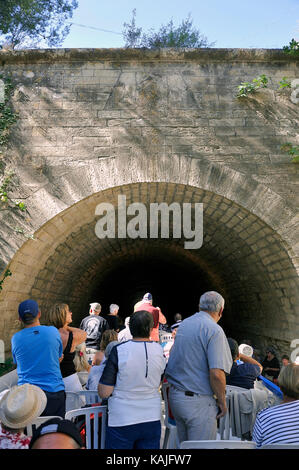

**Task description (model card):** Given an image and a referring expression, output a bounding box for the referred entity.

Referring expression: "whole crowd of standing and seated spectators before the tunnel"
[0,291,299,449]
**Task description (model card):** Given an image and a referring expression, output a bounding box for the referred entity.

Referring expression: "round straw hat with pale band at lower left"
[0,384,47,429]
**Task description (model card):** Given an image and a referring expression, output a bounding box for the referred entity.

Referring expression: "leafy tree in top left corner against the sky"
[0,0,78,49]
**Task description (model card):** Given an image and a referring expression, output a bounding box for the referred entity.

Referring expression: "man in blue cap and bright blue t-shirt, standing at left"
[11,299,65,418]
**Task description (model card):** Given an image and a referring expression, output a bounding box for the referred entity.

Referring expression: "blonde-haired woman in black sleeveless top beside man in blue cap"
[48,303,86,392]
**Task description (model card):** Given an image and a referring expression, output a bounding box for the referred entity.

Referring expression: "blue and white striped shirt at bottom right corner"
[252,400,299,447]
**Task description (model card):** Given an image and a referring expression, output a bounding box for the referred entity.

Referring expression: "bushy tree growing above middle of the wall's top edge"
[123,9,215,49]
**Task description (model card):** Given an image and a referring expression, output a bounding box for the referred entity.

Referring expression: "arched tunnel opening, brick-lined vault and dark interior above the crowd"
[1,182,299,352]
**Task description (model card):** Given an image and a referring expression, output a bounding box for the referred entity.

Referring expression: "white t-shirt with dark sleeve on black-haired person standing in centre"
[100,340,166,427]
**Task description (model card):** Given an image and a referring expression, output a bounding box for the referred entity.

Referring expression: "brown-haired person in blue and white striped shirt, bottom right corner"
[252,363,299,447]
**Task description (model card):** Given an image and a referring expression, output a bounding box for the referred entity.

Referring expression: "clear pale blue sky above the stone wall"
[61,0,299,48]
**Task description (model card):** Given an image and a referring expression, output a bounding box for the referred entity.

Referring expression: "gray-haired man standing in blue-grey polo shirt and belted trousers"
[165,291,233,442]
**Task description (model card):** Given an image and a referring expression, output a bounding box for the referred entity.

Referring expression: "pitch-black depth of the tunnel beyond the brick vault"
[86,253,231,332]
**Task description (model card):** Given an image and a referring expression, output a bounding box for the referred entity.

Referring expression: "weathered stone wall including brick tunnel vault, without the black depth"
[0,49,299,358]
